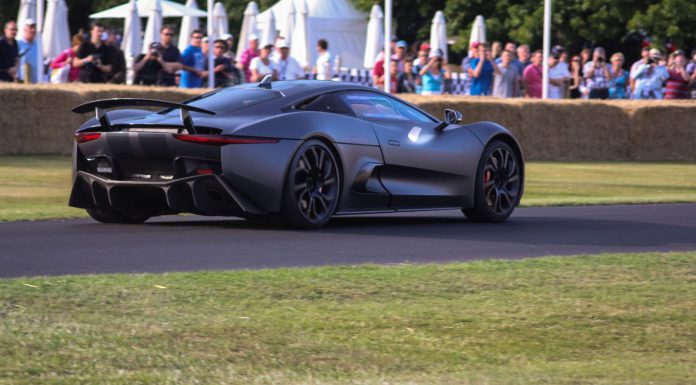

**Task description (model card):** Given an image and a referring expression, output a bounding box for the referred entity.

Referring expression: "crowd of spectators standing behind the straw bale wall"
[0,19,696,99]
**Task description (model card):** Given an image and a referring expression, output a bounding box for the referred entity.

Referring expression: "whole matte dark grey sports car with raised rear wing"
[70,80,524,228]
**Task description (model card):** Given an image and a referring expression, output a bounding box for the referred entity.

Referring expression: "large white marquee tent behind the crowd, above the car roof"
[258,0,367,68]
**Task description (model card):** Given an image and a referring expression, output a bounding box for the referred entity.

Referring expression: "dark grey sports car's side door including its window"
[341,91,482,209]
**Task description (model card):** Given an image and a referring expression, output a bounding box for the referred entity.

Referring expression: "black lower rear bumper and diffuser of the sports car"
[69,171,266,217]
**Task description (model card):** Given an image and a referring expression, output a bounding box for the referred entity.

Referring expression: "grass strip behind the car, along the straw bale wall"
[0,156,696,221]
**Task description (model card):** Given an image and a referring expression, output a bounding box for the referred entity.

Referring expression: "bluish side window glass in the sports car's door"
[341,92,433,123]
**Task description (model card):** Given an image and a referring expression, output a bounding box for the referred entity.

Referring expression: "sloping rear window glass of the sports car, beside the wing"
[163,88,282,113]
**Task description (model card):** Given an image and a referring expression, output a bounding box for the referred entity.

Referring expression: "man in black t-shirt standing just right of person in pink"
[73,23,111,83]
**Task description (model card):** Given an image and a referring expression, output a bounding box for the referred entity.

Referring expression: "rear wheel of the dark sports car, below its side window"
[281,139,341,229]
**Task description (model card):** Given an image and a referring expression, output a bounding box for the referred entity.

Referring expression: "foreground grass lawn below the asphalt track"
[0,252,696,385]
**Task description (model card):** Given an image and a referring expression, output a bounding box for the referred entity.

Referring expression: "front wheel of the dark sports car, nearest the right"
[462,140,522,222]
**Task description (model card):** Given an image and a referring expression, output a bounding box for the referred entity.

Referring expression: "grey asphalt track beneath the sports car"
[0,204,696,277]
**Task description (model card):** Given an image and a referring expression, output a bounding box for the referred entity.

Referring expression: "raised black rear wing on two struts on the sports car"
[72,98,215,134]
